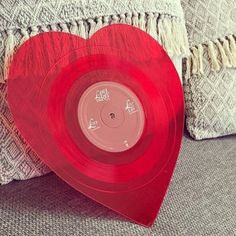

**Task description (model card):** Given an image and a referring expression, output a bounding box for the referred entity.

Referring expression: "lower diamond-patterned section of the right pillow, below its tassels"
[184,57,236,140]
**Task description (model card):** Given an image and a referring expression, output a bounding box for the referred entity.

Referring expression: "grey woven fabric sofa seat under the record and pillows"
[0,136,236,236]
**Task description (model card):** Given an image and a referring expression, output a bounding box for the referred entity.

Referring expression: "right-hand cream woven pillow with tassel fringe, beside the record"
[182,0,236,140]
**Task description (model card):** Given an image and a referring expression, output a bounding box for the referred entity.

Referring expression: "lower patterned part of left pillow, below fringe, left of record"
[0,84,49,184]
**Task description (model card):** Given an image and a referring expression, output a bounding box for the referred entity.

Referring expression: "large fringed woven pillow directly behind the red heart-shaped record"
[0,0,189,184]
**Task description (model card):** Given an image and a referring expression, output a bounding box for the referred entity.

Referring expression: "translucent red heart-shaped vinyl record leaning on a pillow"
[8,25,184,226]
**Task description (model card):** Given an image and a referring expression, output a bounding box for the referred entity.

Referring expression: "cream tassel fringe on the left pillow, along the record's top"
[0,11,188,83]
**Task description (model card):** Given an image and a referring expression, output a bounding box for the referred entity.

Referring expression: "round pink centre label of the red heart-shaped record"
[78,81,145,152]
